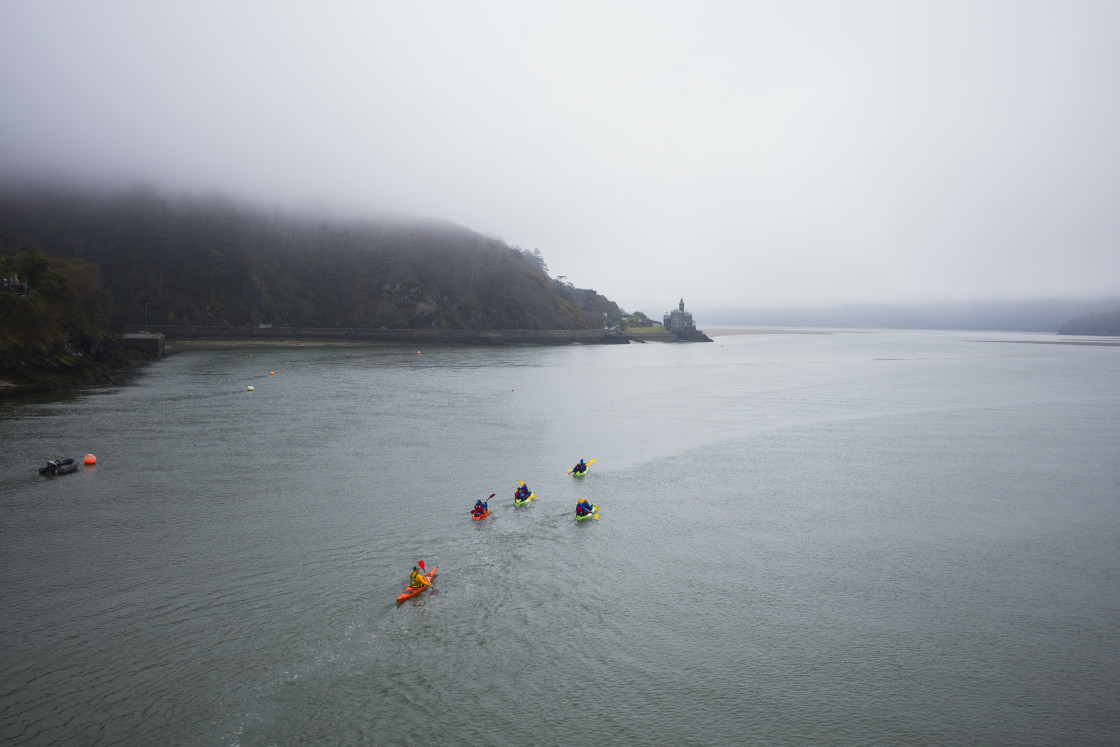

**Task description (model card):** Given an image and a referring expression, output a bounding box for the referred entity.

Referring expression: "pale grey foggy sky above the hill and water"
[0,0,1120,318]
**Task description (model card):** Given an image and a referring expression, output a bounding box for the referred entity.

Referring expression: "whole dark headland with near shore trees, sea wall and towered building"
[0,186,711,393]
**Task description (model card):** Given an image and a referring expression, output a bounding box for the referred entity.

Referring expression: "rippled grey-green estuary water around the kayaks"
[0,332,1120,746]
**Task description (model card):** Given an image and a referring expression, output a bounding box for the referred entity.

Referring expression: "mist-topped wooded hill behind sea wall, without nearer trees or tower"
[0,187,624,329]
